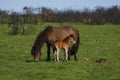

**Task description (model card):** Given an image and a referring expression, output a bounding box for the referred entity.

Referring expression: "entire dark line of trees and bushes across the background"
[0,6,120,34]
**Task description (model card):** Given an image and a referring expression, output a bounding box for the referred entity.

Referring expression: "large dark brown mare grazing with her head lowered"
[31,26,80,61]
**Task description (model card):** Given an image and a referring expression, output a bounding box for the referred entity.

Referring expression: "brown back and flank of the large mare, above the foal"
[47,26,77,41]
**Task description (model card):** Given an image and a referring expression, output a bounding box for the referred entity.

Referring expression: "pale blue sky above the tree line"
[0,0,120,11]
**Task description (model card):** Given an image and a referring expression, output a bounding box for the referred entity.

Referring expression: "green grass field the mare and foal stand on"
[0,23,120,80]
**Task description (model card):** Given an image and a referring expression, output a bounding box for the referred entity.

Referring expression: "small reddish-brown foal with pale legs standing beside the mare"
[54,35,76,61]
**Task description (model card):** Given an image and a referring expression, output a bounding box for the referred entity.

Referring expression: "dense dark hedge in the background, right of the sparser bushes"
[41,6,120,25]
